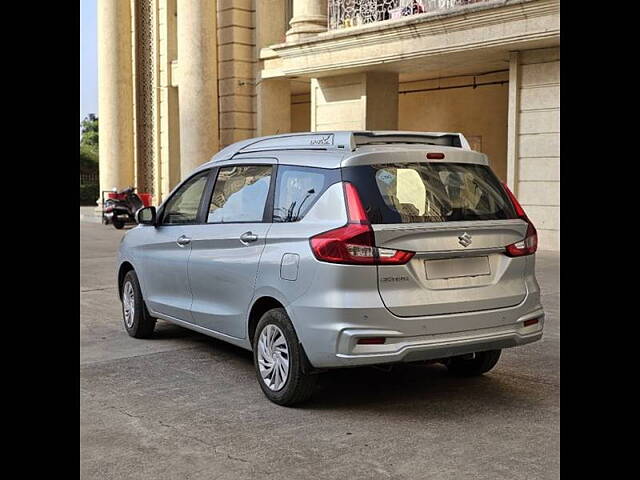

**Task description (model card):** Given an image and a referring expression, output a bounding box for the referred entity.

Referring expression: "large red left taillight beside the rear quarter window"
[310,182,415,265]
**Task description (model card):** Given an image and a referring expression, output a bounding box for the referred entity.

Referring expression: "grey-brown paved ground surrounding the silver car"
[80,222,560,480]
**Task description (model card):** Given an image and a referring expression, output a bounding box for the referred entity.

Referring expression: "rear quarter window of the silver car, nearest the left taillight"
[273,166,340,222]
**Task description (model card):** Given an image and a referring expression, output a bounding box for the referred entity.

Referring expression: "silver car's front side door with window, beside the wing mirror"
[141,170,211,323]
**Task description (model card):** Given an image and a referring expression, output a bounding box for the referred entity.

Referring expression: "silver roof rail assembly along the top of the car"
[212,131,471,161]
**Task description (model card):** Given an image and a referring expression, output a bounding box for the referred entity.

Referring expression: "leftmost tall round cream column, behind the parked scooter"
[97,0,134,202]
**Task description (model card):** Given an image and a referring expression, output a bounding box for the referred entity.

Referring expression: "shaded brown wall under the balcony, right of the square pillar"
[398,74,508,181]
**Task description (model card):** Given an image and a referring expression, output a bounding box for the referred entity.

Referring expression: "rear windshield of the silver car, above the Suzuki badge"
[342,162,517,224]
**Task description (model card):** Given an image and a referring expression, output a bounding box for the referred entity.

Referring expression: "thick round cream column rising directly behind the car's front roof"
[177,0,220,179]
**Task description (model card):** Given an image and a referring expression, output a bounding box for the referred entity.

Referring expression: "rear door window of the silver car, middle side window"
[207,165,273,223]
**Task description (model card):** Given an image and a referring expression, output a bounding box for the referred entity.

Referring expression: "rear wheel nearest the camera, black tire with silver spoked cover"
[253,308,317,406]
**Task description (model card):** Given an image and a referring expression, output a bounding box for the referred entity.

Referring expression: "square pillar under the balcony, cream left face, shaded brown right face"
[311,72,398,132]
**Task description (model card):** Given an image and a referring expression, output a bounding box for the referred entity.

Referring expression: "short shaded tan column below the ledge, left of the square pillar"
[256,78,291,137]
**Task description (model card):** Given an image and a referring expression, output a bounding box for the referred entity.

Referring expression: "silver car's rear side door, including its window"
[189,159,276,338]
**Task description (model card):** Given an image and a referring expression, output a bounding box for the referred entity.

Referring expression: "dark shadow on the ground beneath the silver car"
[153,322,539,416]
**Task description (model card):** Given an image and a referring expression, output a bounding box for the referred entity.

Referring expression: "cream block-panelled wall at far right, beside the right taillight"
[516,48,560,250]
